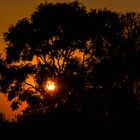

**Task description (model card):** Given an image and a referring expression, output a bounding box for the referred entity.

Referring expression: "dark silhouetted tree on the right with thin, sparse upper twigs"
[91,10,140,120]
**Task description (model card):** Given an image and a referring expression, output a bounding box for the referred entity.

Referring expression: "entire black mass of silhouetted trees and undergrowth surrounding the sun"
[0,1,140,139]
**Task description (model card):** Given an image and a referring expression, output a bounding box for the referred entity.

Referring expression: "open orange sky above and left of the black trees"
[0,0,140,118]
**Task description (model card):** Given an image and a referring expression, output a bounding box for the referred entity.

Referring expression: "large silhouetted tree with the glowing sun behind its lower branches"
[2,2,87,115]
